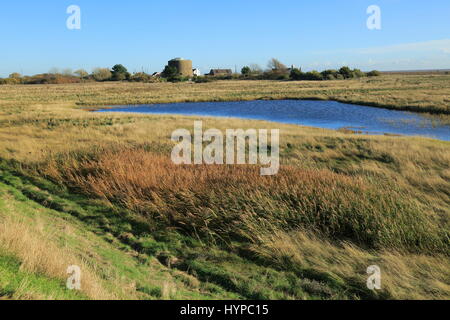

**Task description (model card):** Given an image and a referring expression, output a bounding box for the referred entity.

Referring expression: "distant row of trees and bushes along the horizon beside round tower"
[0,58,381,84]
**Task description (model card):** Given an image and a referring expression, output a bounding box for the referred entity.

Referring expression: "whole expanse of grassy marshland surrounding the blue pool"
[0,74,450,299]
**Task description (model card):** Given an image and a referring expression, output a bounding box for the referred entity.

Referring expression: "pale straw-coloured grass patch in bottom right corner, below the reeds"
[251,230,450,300]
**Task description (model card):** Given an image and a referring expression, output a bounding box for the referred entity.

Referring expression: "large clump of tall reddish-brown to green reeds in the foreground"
[46,149,449,253]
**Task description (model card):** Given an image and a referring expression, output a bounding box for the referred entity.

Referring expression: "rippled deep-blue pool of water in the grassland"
[98,100,450,141]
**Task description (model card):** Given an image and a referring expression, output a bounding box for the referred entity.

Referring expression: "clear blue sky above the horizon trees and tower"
[0,0,450,76]
